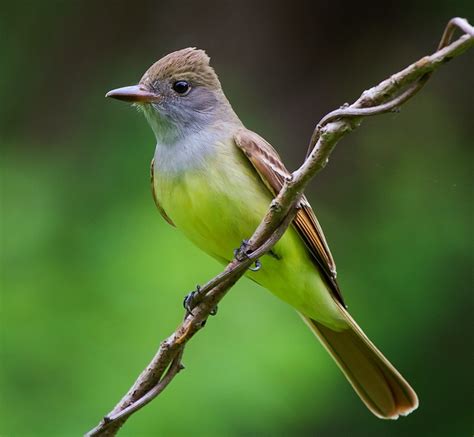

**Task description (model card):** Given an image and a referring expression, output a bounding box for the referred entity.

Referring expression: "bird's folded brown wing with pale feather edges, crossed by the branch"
[234,129,345,306]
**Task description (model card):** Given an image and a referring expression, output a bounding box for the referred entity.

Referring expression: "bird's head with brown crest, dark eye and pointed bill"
[106,48,227,143]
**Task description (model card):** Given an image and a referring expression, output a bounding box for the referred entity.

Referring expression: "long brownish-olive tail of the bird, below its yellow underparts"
[301,307,418,419]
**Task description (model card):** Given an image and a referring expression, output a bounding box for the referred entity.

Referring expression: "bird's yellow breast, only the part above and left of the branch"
[154,145,271,260]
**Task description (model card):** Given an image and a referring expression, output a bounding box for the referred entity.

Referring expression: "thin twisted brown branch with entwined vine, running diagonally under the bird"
[86,18,474,437]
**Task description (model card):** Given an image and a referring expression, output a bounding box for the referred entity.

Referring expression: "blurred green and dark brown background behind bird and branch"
[0,1,474,437]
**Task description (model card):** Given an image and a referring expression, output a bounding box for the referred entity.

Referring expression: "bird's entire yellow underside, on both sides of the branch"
[154,146,346,329]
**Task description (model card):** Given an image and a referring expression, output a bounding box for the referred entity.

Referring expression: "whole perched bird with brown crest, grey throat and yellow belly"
[107,48,418,419]
